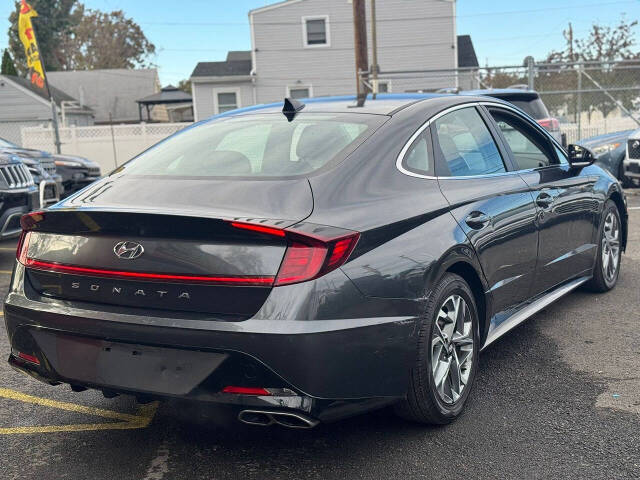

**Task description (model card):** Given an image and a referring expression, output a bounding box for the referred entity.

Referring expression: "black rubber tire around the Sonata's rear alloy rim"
[395,273,479,425]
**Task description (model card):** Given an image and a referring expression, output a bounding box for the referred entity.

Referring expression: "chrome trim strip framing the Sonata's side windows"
[396,101,566,180]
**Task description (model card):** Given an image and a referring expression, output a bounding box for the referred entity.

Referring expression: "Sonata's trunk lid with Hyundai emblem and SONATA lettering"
[21,179,312,319]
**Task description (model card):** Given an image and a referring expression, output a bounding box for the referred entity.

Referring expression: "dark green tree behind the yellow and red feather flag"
[8,0,80,75]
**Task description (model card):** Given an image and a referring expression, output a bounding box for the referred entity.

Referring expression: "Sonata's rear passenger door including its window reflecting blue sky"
[431,106,537,313]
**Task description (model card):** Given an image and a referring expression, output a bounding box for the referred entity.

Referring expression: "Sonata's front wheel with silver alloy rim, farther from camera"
[586,200,622,292]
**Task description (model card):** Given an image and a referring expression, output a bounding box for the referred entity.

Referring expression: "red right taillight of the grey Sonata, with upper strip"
[231,222,360,287]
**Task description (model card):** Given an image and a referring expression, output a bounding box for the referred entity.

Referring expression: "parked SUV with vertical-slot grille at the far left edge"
[0,153,40,240]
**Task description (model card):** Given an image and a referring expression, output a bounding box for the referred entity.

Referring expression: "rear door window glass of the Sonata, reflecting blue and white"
[434,107,506,177]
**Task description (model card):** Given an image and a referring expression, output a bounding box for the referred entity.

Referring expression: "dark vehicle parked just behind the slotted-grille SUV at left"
[0,138,64,207]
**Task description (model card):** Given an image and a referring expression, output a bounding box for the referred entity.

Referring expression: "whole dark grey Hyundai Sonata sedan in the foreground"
[5,95,627,428]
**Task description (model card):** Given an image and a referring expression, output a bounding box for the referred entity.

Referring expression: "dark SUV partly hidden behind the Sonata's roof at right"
[460,88,566,145]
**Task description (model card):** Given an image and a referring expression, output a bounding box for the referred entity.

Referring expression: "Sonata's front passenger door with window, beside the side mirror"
[488,106,598,294]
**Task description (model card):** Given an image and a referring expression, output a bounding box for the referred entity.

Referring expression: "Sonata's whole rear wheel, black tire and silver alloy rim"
[396,273,479,425]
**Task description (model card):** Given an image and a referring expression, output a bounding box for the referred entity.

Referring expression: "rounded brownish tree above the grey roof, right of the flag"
[62,5,156,70]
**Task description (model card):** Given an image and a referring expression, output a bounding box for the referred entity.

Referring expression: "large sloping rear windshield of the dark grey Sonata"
[124,113,388,177]
